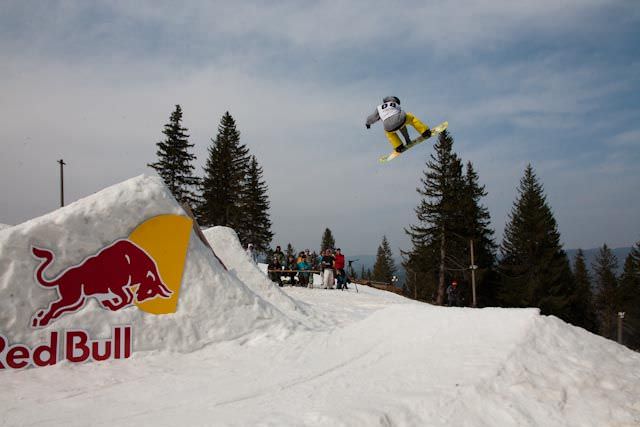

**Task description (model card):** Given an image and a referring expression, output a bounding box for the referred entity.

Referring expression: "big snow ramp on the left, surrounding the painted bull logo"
[0,175,297,352]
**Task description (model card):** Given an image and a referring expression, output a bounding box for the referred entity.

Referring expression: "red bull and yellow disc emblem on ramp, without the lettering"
[31,215,193,328]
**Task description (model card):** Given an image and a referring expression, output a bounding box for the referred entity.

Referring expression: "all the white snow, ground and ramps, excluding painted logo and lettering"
[0,176,640,426]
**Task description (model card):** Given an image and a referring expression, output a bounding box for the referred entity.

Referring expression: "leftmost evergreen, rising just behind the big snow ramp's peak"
[147,105,200,207]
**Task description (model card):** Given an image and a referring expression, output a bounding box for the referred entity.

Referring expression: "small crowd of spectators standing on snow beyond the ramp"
[247,243,349,289]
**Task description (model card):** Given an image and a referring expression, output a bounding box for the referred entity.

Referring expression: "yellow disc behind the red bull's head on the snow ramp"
[129,215,193,314]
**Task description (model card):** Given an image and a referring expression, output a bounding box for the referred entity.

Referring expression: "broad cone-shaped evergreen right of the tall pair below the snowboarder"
[500,165,574,320]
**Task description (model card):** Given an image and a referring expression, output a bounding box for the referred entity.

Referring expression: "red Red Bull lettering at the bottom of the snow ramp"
[0,326,133,371]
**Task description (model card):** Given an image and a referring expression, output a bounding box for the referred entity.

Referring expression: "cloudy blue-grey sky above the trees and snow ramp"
[0,0,640,254]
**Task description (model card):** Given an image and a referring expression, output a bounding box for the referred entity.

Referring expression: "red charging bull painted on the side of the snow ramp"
[32,239,173,328]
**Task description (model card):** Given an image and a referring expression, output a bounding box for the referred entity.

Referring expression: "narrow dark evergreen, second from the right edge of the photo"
[592,244,622,339]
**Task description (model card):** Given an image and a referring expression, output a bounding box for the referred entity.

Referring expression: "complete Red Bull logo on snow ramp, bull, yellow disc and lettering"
[0,215,193,370]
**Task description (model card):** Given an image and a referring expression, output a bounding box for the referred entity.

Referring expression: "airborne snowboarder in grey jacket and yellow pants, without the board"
[365,96,431,153]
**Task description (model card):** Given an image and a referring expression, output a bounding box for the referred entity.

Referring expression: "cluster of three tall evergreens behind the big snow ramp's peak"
[148,105,273,252]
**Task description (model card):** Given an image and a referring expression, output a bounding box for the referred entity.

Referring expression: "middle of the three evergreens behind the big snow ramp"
[198,111,250,236]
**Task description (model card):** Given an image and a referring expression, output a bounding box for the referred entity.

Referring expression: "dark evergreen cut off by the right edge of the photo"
[620,242,640,351]
